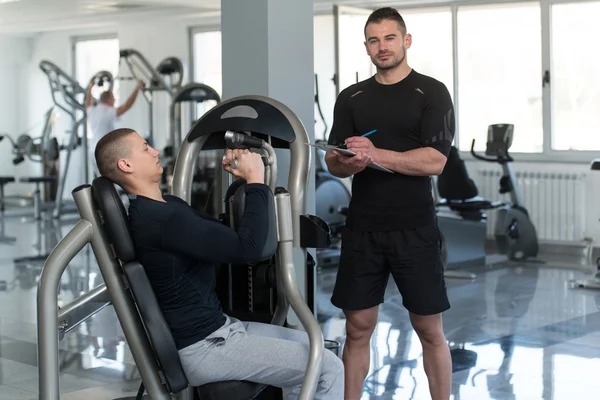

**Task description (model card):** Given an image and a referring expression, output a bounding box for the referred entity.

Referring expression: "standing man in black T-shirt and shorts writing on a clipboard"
[325,7,455,400]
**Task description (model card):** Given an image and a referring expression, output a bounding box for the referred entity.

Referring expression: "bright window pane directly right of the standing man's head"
[400,8,454,101]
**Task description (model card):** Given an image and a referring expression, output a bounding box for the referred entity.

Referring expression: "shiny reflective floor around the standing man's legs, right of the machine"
[319,257,600,400]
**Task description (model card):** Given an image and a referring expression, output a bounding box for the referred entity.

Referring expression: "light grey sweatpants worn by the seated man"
[179,316,344,400]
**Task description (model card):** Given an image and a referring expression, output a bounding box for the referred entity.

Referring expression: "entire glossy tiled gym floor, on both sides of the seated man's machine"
[0,211,600,400]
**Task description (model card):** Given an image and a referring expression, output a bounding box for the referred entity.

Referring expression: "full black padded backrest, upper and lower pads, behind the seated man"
[92,177,188,393]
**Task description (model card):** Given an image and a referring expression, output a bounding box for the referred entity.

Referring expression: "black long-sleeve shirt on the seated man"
[129,184,271,349]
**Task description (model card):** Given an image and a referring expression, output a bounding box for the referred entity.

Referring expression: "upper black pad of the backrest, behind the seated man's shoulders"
[92,176,135,263]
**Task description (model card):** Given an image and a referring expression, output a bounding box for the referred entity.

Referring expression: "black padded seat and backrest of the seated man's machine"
[92,177,276,400]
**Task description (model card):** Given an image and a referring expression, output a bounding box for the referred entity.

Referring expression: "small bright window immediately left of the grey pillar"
[192,31,223,118]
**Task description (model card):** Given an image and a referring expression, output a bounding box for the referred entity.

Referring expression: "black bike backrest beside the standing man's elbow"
[437,146,478,201]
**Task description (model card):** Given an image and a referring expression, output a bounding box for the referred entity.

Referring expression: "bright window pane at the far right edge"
[550,2,600,150]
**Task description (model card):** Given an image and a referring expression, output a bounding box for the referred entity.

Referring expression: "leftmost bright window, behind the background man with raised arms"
[75,38,119,104]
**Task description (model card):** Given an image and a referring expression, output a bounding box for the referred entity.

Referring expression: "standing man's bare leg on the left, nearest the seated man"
[342,306,379,400]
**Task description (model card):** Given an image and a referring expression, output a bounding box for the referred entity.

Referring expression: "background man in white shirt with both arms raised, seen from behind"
[85,80,144,175]
